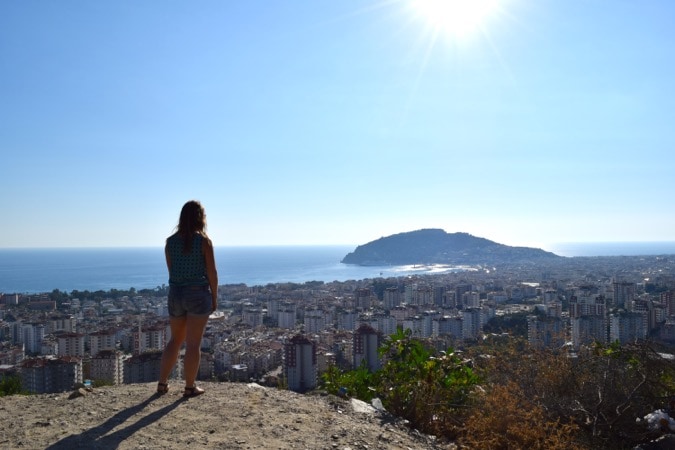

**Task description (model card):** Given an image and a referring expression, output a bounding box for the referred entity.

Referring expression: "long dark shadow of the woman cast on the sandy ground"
[47,394,183,450]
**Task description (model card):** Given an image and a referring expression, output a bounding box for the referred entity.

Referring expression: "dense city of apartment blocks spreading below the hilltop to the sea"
[0,256,675,393]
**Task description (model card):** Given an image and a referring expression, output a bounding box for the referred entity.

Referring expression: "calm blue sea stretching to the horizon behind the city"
[0,242,675,294]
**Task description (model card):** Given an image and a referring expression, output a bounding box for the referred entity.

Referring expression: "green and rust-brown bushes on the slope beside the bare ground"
[323,330,675,449]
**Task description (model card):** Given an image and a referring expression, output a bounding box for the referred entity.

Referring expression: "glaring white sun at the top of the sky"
[411,0,499,39]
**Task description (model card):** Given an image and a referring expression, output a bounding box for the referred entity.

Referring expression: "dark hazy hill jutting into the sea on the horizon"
[341,228,562,266]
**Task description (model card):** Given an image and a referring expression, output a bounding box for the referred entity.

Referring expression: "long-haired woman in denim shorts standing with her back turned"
[157,200,218,397]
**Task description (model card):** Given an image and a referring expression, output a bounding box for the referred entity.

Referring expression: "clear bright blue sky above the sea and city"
[0,0,675,248]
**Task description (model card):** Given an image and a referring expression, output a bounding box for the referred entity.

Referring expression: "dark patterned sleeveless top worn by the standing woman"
[166,233,209,286]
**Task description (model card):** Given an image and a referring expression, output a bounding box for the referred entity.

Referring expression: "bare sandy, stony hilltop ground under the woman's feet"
[0,382,446,450]
